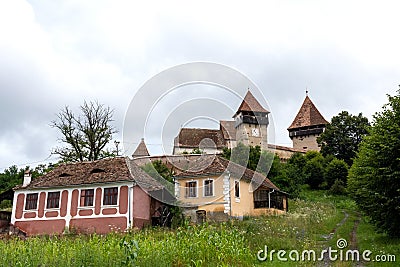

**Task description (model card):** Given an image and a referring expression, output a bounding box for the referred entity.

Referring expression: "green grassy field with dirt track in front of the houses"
[0,191,400,266]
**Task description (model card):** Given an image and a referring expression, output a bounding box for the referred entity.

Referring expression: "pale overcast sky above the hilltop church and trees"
[0,0,400,170]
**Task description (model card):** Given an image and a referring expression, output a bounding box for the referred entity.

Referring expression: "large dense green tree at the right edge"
[348,89,400,236]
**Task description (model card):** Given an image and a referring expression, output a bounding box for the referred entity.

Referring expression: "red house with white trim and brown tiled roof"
[11,158,172,235]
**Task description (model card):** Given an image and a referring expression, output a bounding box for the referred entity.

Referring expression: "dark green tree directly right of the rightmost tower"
[317,111,369,166]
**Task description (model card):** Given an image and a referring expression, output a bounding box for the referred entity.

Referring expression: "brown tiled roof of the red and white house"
[15,157,162,191]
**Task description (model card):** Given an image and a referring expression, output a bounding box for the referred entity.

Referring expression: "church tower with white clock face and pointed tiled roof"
[233,90,269,150]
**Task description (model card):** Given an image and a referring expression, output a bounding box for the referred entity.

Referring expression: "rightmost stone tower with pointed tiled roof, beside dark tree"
[288,92,328,151]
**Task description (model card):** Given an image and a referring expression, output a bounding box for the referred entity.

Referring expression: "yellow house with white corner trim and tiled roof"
[174,155,288,221]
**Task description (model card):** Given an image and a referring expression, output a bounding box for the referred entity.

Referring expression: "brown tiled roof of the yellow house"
[175,155,279,190]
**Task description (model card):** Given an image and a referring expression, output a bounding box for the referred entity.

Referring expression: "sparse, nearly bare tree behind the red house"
[51,101,116,162]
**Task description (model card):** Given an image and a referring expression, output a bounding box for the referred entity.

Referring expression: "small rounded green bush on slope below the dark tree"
[325,159,349,191]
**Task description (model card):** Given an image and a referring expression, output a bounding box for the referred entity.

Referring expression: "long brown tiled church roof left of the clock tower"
[175,128,225,148]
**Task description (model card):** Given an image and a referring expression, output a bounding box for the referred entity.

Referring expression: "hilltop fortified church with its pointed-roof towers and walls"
[136,90,328,161]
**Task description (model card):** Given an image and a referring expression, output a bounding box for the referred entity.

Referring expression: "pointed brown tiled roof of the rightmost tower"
[288,96,328,130]
